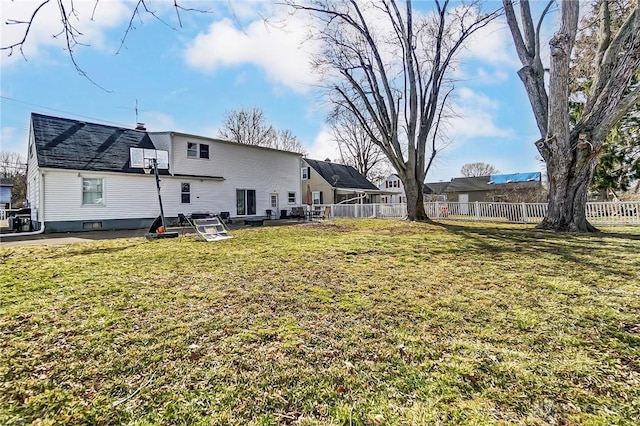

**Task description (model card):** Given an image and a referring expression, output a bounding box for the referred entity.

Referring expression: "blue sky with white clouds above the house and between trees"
[0,0,552,181]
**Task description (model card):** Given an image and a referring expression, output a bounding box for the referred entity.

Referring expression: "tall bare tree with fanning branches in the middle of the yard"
[288,0,499,220]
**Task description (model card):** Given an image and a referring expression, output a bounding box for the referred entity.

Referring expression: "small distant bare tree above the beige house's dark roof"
[330,109,388,182]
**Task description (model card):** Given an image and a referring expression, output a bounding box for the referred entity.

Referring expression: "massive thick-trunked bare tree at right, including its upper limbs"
[503,0,640,231]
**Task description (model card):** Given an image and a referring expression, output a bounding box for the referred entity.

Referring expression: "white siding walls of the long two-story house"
[35,133,301,222]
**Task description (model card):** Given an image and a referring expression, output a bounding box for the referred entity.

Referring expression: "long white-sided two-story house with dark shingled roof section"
[27,114,301,232]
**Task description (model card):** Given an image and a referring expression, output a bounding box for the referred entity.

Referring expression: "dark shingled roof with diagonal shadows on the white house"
[31,113,168,174]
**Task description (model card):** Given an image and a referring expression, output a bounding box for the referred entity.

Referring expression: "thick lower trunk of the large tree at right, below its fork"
[538,137,598,232]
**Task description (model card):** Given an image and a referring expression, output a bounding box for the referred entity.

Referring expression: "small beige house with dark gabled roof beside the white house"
[300,158,385,204]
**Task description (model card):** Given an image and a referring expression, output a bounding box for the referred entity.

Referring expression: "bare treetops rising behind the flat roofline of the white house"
[218,107,306,155]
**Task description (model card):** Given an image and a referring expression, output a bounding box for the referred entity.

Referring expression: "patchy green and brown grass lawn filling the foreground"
[0,220,640,425]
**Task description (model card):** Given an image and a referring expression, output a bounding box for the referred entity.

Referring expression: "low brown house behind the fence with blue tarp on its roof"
[424,172,545,203]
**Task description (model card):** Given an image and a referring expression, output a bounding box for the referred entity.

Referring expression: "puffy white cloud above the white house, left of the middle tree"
[185,10,318,92]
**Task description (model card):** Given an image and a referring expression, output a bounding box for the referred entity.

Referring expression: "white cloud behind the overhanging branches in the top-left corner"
[0,0,131,67]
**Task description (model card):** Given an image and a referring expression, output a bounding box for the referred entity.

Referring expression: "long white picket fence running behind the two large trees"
[322,201,640,225]
